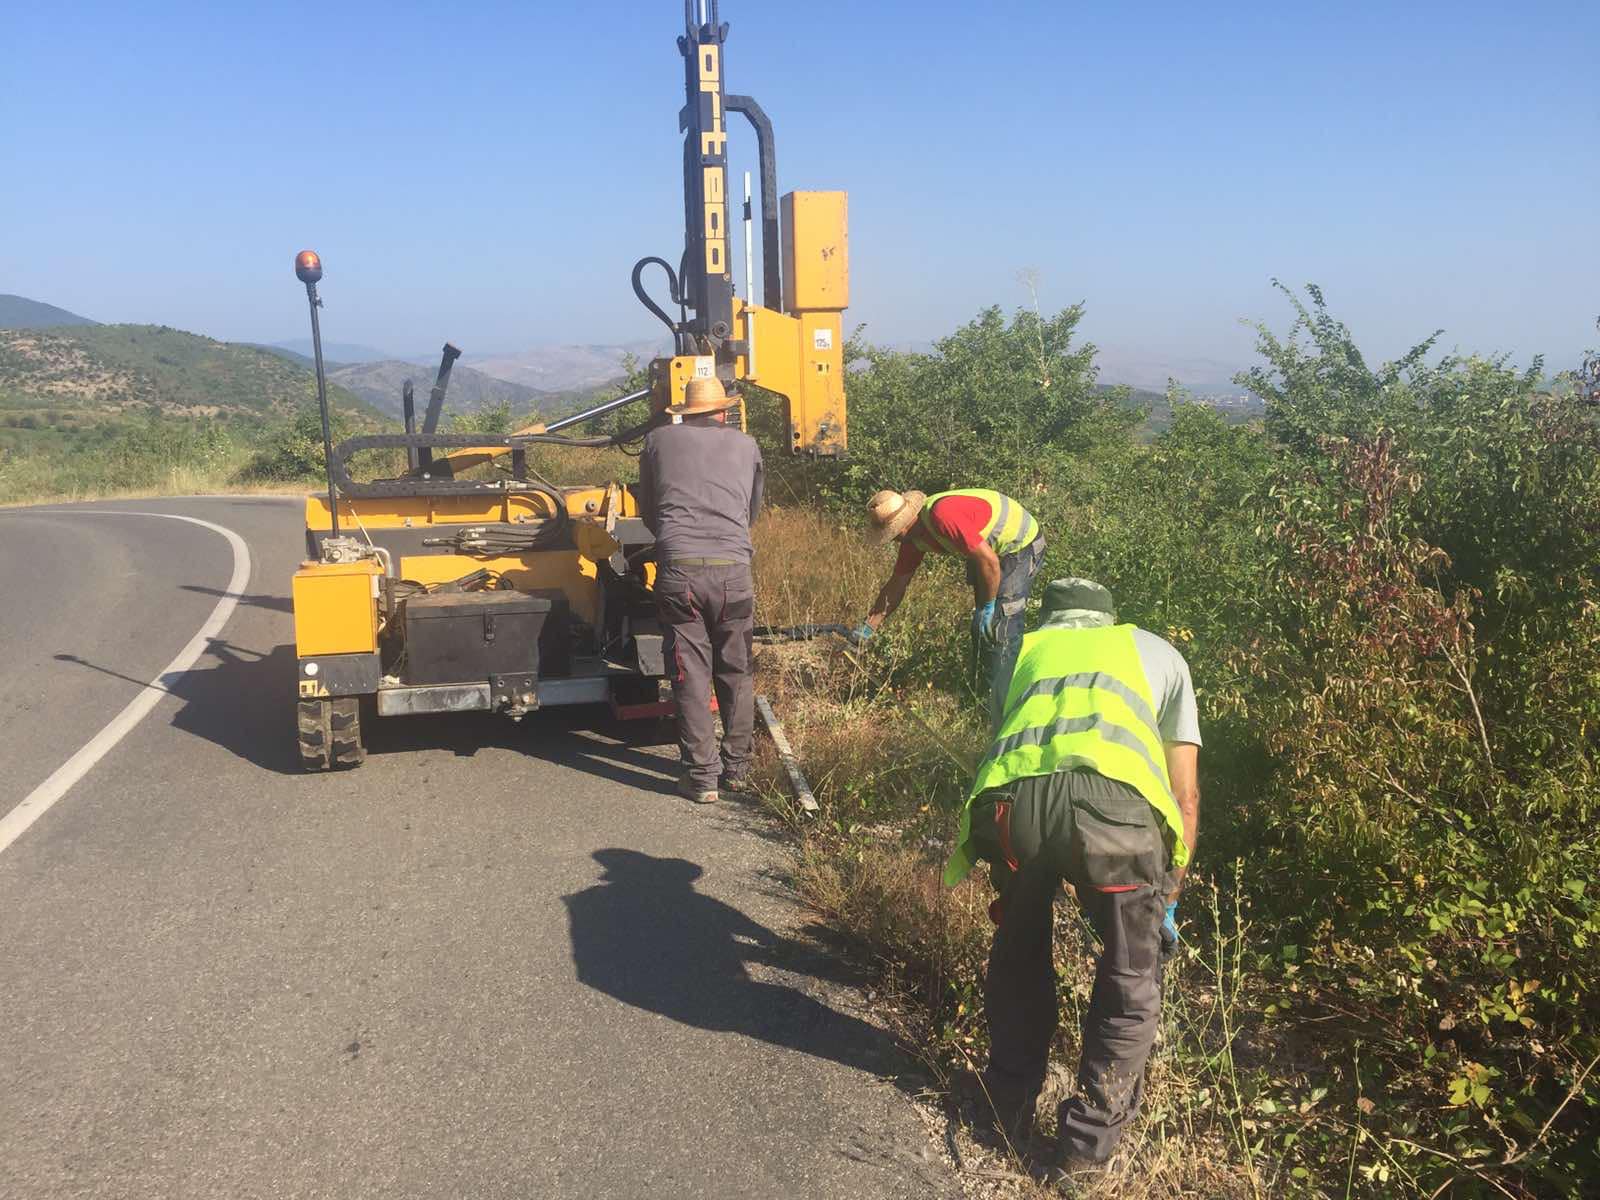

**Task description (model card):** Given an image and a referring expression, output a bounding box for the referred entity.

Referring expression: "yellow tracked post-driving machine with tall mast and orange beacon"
[293,0,850,770]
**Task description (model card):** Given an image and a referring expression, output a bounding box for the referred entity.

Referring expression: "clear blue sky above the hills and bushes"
[0,0,1600,377]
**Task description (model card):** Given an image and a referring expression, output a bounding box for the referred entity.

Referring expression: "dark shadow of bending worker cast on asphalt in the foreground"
[563,848,922,1091]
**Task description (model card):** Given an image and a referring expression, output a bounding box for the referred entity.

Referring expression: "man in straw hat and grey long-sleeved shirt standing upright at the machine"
[637,379,762,803]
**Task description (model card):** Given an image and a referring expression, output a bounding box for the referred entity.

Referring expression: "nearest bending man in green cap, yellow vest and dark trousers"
[944,579,1200,1189]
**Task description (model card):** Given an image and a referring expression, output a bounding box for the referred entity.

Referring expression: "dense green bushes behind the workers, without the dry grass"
[821,288,1600,1197]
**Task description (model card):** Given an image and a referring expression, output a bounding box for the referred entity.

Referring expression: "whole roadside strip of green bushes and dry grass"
[758,288,1600,1198]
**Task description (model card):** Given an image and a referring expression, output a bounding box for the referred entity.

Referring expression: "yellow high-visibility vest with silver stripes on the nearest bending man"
[944,626,1189,886]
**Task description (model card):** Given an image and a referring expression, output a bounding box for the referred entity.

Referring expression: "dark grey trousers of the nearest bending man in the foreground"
[973,770,1171,1162]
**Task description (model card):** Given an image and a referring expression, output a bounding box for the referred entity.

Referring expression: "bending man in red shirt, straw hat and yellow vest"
[856,488,1045,728]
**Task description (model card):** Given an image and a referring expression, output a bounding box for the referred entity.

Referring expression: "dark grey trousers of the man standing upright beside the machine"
[656,560,755,792]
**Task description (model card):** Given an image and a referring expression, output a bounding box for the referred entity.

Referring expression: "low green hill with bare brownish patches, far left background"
[0,325,365,419]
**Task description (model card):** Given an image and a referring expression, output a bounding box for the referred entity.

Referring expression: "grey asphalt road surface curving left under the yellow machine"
[0,499,960,1200]
